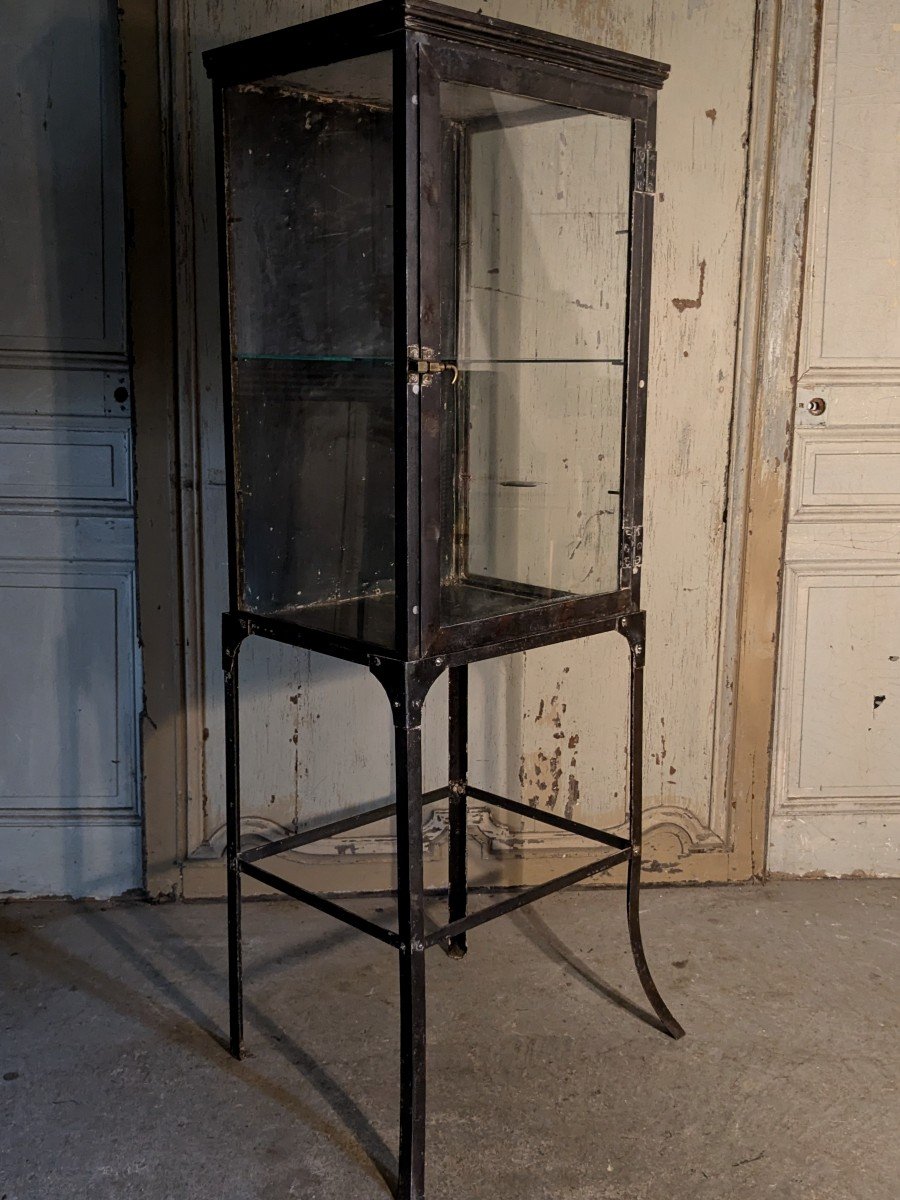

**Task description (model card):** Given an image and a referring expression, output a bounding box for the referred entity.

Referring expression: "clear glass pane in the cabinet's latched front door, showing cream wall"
[440,83,631,625]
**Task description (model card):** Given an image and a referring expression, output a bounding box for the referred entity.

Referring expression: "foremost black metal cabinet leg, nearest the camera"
[395,716,425,1200]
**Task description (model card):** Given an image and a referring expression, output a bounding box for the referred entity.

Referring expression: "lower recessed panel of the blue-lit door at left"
[0,560,139,822]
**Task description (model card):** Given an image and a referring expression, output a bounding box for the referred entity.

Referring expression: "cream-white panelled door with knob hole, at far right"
[768,0,900,875]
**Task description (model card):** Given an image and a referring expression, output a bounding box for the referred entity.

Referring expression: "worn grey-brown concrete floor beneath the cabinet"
[0,881,900,1200]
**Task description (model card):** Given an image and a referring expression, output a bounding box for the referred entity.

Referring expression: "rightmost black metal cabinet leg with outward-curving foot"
[623,613,684,1038]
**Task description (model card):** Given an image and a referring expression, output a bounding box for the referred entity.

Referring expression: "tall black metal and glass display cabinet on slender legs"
[204,0,683,1200]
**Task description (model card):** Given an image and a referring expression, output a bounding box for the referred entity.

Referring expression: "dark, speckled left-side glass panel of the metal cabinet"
[224,53,395,646]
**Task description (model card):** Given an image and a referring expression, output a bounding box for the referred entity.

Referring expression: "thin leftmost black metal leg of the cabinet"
[224,642,244,1058]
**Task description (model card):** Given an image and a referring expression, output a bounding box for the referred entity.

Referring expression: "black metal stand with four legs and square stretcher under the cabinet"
[223,612,684,1200]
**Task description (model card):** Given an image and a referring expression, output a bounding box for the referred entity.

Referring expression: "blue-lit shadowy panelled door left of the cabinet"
[0,0,142,895]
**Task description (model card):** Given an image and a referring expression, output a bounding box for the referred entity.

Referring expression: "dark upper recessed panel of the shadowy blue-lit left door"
[0,0,126,355]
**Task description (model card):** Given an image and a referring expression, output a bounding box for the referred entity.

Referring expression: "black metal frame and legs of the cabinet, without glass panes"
[204,0,683,1200]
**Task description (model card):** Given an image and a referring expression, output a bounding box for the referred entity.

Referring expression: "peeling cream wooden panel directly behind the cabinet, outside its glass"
[172,0,756,887]
